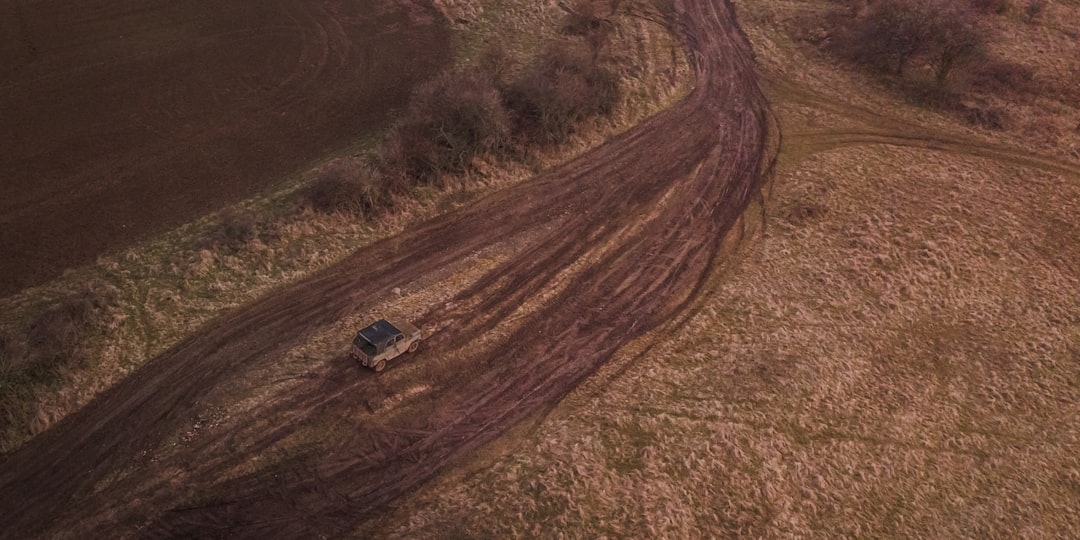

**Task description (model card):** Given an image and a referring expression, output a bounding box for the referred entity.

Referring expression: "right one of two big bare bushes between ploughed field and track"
[507,43,622,144]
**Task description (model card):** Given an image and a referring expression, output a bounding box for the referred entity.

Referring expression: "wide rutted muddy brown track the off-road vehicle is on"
[0,0,775,538]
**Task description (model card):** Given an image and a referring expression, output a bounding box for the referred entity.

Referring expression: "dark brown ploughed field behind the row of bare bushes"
[0,0,450,296]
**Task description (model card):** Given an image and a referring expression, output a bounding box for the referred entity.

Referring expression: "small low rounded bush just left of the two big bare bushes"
[300,159,389,216]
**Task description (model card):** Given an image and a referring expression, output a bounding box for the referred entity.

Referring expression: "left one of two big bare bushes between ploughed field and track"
[380,71,510,183]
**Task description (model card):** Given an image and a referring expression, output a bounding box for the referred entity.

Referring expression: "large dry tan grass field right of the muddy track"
[362,1,1080,538]
